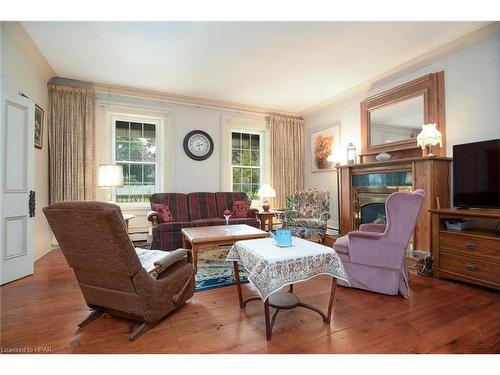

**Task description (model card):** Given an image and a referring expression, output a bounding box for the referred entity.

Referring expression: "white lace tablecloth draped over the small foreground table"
[226,237,349,301]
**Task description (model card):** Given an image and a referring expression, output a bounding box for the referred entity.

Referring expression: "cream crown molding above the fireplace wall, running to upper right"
[300,21,500,117]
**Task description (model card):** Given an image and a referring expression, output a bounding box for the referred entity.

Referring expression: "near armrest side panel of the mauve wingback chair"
[347,231,402,269]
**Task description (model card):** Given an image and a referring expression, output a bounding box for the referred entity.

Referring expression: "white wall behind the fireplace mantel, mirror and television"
[305,37,500,229]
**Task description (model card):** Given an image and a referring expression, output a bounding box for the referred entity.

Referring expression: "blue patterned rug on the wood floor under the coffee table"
[195,246,248,292]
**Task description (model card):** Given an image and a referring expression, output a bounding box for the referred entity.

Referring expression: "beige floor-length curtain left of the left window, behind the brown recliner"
[48,84,95,203]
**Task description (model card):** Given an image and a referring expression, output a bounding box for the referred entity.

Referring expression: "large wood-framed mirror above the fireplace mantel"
[361,72,445,162]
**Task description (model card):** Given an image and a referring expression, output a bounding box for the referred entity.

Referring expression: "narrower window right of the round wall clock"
[231,131,262,200]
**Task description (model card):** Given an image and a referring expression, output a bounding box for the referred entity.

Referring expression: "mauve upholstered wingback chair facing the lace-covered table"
[333,189,424,298]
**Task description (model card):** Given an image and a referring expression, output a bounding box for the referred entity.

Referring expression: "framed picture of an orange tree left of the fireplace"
[311,124,340,172]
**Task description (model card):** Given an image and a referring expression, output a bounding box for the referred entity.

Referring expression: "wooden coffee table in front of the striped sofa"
[181,224,269,273]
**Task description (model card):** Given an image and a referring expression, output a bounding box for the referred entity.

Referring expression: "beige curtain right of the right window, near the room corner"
[269,114,304,208]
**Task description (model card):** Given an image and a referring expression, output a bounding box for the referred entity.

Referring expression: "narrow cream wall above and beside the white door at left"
[1,22,55,259]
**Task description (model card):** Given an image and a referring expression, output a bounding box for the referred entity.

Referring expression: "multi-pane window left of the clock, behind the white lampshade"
[114,119,158,203]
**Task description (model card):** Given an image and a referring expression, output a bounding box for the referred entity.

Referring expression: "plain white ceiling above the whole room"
[22,22,488,112]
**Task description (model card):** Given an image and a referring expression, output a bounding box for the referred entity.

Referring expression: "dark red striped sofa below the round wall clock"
[150,192,259,251]
